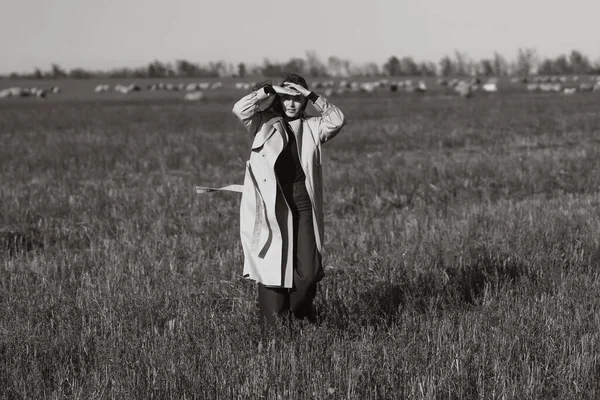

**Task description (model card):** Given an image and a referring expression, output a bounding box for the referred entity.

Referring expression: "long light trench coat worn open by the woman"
[233,89,346,288]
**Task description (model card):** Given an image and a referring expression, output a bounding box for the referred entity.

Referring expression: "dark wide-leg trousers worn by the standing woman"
[258,182,324,323]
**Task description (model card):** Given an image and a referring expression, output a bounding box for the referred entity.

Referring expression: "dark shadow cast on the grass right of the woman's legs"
[323,248,536,329]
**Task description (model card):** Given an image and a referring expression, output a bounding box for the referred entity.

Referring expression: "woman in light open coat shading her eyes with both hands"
[233,74,345,323]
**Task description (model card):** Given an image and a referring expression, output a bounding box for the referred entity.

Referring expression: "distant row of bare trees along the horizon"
[3,48,600,79]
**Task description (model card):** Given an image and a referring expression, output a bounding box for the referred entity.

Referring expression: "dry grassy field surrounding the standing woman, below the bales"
[0,82,600,399]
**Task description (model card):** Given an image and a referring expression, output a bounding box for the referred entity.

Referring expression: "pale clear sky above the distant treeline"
[0,0,600,74]
